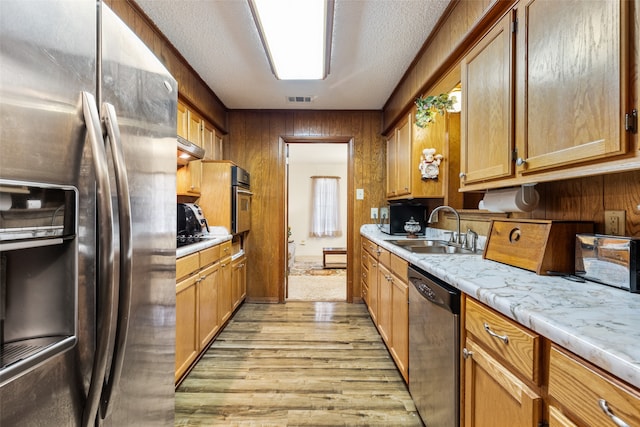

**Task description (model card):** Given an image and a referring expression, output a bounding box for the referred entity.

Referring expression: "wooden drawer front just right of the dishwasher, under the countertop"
[465,298,540,385]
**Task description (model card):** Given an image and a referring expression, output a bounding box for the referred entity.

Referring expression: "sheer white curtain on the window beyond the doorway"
[310,176,342,237]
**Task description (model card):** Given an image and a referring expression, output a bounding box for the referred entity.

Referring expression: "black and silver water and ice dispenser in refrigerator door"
[0,180,78,386]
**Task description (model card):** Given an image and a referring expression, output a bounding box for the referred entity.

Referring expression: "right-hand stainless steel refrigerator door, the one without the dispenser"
[93,5,178,426]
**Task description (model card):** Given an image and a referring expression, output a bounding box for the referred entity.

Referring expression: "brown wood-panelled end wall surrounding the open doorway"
[225,111,386,302]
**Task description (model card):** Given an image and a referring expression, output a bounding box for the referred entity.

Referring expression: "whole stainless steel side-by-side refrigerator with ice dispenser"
[0,0,177,427]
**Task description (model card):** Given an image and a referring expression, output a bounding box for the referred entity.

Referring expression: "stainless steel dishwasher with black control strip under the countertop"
[409,265,460,427]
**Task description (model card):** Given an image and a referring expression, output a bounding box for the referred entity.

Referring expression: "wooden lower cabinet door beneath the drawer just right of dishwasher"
[464,339,542,427]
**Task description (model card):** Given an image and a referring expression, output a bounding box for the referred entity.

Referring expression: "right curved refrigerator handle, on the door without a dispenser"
[100,102,133,419]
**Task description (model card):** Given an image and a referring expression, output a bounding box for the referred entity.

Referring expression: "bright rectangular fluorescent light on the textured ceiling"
[249,0,334,80]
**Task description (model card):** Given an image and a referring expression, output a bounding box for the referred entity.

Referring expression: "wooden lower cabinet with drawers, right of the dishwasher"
[462,297,640,427]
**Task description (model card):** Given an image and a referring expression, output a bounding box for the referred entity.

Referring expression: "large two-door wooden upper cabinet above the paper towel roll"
[461,0,630,190]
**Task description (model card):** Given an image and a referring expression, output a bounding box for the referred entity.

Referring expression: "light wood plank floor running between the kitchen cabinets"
[175,302,423,426]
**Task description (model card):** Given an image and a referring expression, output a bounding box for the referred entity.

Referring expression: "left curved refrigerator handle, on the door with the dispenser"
[82,92,118,427]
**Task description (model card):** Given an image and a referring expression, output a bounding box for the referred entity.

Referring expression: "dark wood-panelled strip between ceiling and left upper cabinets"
[104,0,227,133]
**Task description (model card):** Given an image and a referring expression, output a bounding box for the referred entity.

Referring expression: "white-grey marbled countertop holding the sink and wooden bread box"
[360,224,640,388]
